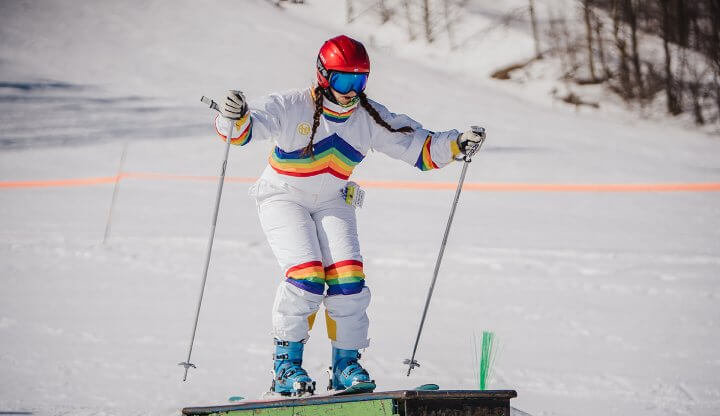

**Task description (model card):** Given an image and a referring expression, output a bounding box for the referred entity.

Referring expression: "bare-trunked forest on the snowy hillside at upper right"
[282,0,720,125]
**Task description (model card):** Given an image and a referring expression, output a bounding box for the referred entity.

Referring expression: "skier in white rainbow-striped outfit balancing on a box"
[215,36,481,395]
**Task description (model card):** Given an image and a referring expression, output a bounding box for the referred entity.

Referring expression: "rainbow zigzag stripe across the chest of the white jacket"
[268,133,365,179]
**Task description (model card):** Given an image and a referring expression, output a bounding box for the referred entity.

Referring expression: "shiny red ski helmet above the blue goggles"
[317,35,370,88]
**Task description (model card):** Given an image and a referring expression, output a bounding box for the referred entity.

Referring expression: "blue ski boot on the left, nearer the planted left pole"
[270,339,315,396]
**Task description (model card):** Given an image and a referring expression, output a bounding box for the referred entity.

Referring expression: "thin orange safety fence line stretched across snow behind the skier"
[0,172,720,192]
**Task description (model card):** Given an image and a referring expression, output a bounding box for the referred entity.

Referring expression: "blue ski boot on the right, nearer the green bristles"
[328,347,375,393]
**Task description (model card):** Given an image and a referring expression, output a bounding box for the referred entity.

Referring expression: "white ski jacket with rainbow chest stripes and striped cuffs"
[215,88,460,200]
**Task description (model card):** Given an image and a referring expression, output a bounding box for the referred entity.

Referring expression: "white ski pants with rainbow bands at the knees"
[250,179,370,349]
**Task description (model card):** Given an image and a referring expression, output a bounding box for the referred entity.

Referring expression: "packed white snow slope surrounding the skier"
[0,0,720,415]
